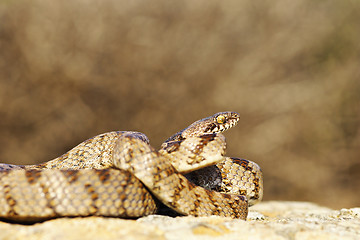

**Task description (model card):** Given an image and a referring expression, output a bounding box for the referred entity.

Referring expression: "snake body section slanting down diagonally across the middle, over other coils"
[113,137,248,219]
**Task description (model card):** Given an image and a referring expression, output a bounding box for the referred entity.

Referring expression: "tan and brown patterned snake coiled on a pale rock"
[0,111,263,222]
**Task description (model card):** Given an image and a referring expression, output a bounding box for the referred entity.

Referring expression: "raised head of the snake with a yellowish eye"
[181,112,240,138]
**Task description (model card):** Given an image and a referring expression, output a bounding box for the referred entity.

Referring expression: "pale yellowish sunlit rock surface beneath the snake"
[0,201,360,240]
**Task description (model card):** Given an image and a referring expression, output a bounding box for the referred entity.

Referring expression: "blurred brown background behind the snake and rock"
[0,0,360,208]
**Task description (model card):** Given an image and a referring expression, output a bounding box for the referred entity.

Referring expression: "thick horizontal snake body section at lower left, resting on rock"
[0,169,157,221]
